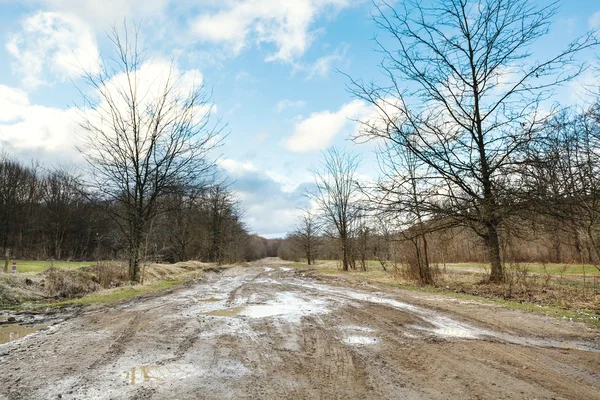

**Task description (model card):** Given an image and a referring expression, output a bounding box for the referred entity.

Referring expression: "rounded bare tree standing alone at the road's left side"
[80,25,219,282]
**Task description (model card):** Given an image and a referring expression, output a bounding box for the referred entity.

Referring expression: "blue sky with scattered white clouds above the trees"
[0,0,600,237]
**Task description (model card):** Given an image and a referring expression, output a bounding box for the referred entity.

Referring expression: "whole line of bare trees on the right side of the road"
[278,0,600,283]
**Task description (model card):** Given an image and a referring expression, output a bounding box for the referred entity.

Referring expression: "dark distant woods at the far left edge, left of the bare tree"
[0,154,109,259]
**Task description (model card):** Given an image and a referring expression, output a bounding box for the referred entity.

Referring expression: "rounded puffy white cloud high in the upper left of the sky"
[6,11,99,88]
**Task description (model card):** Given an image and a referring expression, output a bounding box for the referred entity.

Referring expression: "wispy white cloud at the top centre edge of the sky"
[193,0,351,62]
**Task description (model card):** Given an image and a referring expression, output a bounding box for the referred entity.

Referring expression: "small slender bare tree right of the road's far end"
[309,148,360,271]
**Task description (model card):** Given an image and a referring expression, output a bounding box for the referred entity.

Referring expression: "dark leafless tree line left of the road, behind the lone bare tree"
[0,154,276,263]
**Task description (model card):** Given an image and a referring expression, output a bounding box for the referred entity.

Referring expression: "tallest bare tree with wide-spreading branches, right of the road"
[350,0,598,282]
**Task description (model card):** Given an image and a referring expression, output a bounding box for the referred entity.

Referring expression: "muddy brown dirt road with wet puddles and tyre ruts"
[0,261,600,399]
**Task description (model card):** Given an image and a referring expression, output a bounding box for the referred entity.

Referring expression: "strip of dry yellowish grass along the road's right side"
[292,261,600,326]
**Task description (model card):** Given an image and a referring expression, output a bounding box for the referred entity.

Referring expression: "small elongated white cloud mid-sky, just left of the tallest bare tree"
[283,100,372,153]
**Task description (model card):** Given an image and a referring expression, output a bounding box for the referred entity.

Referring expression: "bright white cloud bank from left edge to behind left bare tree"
[0,60,209,163]
